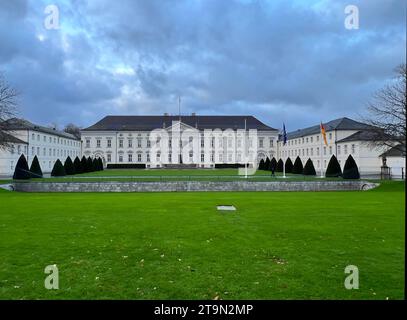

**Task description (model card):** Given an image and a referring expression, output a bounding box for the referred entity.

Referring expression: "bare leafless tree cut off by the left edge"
[0,74,18,149]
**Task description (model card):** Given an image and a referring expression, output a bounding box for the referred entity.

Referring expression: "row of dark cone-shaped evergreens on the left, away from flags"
[13,154,103,180]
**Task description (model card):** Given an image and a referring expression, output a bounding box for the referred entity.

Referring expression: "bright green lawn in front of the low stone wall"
[0,182,405,299]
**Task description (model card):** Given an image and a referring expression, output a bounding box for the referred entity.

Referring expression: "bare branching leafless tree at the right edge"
[364,64,407,156]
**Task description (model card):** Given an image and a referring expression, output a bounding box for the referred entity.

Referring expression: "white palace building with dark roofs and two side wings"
[0,114,405,177]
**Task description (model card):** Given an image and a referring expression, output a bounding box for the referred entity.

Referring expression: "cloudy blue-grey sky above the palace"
[0,0,406,131]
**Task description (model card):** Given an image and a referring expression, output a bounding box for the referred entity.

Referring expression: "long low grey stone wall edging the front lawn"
[13,180,378,192]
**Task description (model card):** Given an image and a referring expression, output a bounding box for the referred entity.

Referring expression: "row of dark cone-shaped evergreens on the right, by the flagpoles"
[258,155,360,179]
